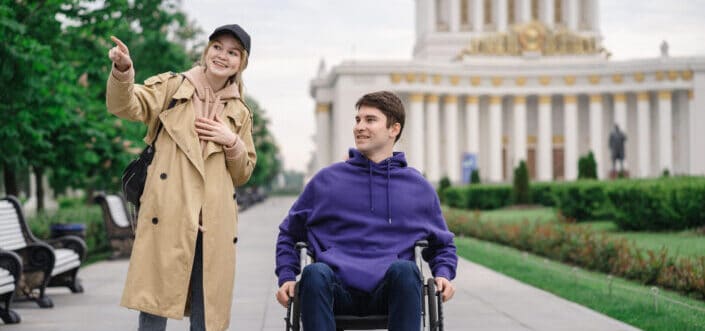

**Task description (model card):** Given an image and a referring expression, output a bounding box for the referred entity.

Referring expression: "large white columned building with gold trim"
[311,0,705,182]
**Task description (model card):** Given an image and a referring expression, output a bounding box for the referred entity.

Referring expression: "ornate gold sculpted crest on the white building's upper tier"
[456,20,611,60]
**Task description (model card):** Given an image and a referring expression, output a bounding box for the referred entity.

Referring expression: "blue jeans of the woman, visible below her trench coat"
[137,232,206,331]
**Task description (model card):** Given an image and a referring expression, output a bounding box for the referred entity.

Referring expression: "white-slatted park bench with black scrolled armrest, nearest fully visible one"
[0,196,86,308]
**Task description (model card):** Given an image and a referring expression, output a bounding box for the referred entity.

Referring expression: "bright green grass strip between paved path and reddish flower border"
[456,238,705,330]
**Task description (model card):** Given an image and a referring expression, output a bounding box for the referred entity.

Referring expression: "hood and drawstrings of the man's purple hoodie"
[346,148,406,224]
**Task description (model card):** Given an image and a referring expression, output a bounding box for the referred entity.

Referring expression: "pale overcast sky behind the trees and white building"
[182,0,705,171]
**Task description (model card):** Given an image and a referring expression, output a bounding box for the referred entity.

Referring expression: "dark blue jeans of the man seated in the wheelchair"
[299,261,422,331]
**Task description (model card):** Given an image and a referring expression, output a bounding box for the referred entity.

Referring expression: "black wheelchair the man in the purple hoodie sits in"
[284,240,443,331]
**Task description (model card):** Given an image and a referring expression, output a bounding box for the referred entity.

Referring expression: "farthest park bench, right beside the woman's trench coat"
[93,193,134,258]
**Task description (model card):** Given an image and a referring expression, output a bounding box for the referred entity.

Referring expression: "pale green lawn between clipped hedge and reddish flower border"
[470,207,705,257]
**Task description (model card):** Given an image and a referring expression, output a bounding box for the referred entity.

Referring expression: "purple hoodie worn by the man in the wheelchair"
[276,148,458,293]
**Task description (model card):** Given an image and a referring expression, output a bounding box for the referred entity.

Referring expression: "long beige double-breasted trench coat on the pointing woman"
[106,73,256,330]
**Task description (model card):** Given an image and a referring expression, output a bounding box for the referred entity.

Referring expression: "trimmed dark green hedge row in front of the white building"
[443,177,705,230]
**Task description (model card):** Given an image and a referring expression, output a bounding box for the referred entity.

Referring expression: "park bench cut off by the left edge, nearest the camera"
[0,249,22,324]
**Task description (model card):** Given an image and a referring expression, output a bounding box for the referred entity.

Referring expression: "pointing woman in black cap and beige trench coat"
[106,24,256,330]
